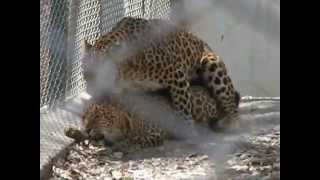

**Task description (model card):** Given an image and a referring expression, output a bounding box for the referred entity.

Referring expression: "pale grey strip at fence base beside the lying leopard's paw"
[40,93,88,170]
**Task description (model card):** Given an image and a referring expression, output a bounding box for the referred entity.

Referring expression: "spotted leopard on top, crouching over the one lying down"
[83,17,240,129]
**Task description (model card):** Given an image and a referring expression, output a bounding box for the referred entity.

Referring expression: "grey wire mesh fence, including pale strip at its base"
[40,0,170,174]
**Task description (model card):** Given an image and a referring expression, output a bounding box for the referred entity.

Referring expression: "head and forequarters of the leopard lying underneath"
[65,98,172,153]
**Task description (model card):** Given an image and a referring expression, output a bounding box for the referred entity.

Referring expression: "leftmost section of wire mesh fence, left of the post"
[40,0,68,107]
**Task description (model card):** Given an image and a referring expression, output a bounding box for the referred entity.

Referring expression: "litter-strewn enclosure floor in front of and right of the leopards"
[45,100,280,179]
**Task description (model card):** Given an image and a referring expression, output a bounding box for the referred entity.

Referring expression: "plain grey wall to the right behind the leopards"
[175,0,280,96]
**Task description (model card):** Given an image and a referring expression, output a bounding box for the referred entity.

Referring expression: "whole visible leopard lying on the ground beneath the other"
[65,86,217,151]
